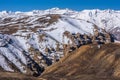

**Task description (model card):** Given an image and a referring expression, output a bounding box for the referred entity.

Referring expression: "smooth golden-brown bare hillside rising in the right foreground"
[41,43,120,80]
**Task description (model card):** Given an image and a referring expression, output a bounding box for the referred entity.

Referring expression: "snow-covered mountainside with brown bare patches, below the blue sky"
[0,8,120,73]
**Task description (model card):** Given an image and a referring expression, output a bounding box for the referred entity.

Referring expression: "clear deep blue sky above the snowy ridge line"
[0,0,120,11]
